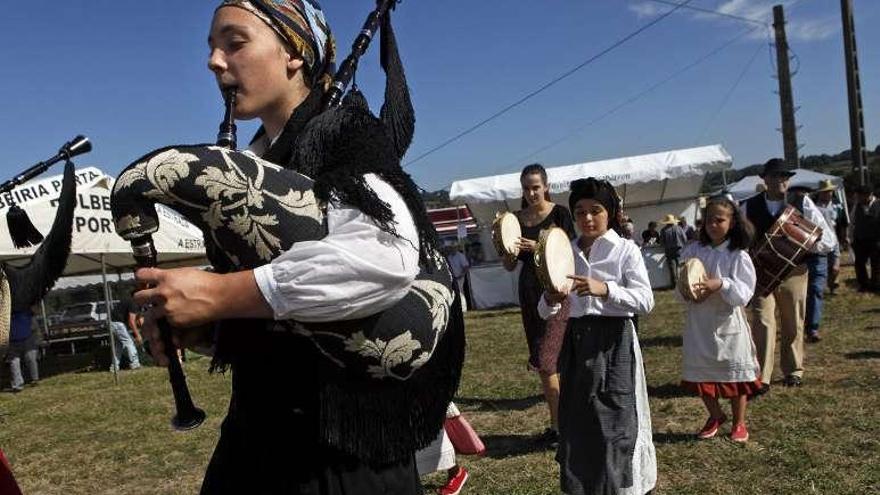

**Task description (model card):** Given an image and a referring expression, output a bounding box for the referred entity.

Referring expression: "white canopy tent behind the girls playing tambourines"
[449,145,733,308]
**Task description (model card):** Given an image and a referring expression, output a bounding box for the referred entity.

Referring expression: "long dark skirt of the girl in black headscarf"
[556,315,638,495]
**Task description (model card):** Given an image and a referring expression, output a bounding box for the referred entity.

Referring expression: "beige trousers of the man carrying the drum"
[751,265,807,385]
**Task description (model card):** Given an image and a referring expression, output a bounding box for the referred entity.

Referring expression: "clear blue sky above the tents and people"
[0,0,880,190]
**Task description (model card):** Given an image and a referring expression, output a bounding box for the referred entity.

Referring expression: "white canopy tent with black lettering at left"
[0,167,206,275]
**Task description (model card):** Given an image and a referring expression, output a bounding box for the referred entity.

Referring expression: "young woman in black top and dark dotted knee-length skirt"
[504,163,575,448]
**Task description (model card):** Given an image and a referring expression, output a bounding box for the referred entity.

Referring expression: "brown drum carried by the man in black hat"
[750,205,822,297]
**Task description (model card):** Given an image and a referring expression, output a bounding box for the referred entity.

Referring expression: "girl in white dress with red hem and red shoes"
[681,196,761,442]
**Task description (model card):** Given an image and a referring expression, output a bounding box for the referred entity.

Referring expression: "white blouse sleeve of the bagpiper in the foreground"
[254,174,419,322]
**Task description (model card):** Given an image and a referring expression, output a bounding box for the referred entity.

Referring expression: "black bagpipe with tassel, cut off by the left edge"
[0,135,86,358]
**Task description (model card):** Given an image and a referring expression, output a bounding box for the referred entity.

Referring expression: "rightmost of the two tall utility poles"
[840,0,868,186]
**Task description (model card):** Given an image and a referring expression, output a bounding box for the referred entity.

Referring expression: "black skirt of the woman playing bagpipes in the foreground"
[201,356,423,495]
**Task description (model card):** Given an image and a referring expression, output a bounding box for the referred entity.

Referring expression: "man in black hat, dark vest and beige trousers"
[742,158,835,393]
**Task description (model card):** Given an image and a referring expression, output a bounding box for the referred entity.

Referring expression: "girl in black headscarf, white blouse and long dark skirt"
[537,178,657,494]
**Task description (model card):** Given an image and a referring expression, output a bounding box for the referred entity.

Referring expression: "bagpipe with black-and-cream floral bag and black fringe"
[111,0,463,459]
